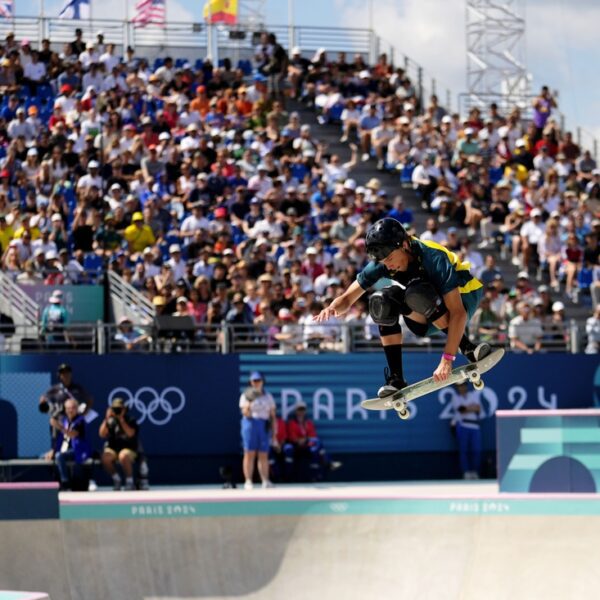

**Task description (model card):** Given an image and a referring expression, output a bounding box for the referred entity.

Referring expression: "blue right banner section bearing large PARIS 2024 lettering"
[240,352,600,453]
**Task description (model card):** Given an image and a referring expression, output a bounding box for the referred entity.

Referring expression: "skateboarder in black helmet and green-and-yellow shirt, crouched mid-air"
[317,218,491,398]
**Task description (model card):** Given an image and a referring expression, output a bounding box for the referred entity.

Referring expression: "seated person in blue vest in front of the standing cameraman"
[46,398,91,490]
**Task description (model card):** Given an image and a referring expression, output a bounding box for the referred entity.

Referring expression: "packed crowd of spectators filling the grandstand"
[0,31,600,351]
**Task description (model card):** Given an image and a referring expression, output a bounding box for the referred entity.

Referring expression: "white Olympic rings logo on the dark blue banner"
[108,387,185,426]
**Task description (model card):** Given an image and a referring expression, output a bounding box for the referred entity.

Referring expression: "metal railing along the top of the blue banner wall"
[0,316,586,355]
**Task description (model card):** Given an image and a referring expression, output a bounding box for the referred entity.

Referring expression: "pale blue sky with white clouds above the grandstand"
[23,0,600,149]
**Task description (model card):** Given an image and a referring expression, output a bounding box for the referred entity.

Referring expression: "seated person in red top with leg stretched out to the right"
[283,401,342,481]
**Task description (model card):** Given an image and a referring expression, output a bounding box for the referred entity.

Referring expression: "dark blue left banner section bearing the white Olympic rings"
[0,354,240,457]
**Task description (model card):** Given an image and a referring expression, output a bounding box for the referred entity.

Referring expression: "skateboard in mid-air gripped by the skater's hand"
[360,348,504,419]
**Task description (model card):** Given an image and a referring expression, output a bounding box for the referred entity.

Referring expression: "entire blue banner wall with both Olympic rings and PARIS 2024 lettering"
[0,352,600,457]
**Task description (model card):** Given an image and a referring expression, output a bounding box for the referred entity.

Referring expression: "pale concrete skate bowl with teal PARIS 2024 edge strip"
[0,482,600,600]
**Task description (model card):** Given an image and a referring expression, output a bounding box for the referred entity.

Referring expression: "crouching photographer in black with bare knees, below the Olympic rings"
[100,398,139,490]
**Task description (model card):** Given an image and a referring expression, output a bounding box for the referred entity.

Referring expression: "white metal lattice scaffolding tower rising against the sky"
[466,0,530,111]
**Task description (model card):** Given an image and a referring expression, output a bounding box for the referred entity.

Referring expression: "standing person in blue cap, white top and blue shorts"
[240,371,277,490]
